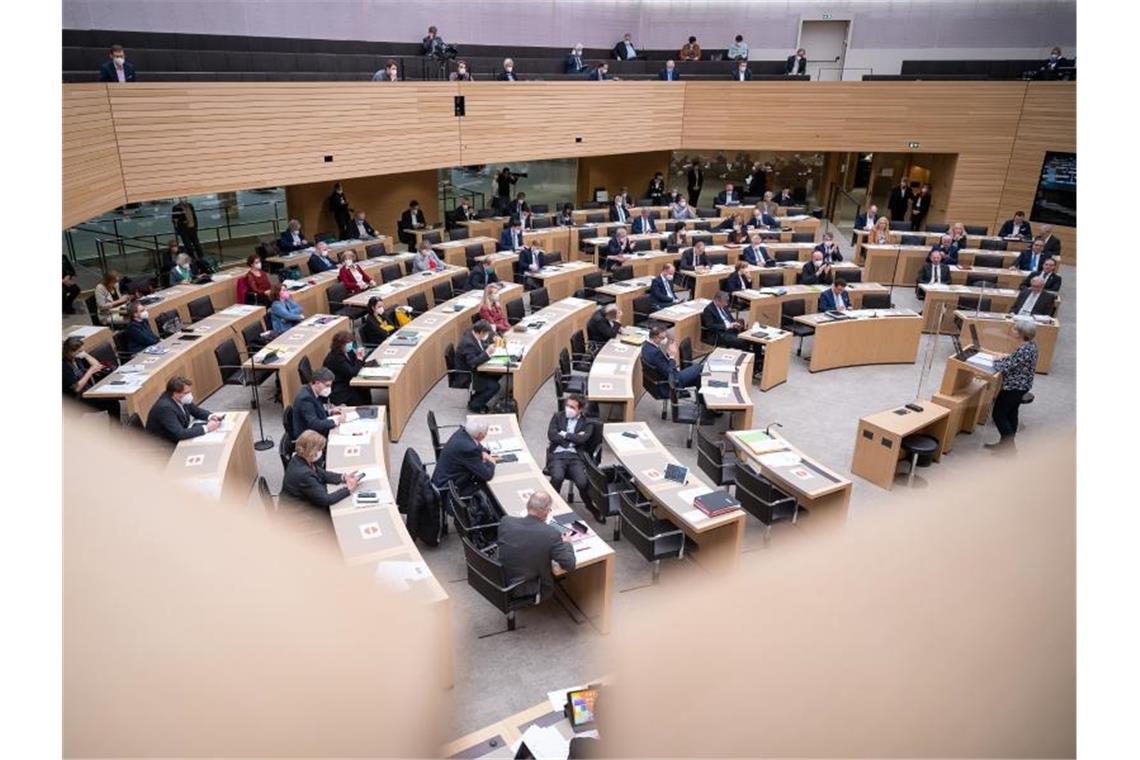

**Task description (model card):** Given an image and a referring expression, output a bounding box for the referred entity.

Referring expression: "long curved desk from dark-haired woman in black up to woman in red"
[352,283,522,441]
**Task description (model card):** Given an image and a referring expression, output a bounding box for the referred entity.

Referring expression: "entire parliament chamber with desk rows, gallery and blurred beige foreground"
[53,0,1077,758]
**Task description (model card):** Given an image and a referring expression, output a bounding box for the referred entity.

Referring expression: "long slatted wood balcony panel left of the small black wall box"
[111,82,459,198]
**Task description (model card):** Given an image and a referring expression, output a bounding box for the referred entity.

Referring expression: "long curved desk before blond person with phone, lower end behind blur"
[325,407,454,688]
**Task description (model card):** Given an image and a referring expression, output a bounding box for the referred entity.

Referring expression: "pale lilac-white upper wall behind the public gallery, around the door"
[63,0,1076,79]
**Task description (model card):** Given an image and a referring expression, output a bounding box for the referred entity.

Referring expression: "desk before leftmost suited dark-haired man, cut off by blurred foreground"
[166,411,258,504]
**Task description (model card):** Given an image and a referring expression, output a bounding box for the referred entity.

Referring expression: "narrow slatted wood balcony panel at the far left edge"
[62,84,127,228]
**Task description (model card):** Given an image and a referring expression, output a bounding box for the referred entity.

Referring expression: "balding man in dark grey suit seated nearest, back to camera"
[494,489,576,599]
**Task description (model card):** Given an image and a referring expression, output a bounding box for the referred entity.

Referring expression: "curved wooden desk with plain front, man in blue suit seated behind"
[796,309,922,373]
